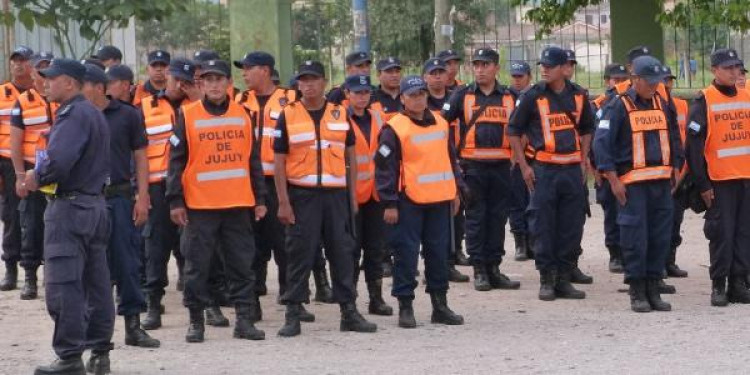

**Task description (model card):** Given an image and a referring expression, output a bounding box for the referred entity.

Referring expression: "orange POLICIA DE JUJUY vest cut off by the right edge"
[703,85,750,181]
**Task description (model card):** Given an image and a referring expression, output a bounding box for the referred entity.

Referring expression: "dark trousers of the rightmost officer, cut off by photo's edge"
[703,179,750,279]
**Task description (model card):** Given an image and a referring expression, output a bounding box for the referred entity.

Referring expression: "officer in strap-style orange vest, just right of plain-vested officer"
[443,48,521,291]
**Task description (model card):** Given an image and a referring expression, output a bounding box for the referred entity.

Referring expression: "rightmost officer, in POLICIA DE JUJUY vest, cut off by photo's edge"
[687,48,750,306]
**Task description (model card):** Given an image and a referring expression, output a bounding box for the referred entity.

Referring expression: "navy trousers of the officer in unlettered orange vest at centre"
[391,195,451,299]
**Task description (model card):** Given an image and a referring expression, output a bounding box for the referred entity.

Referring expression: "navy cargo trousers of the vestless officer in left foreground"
[44,195,115,358]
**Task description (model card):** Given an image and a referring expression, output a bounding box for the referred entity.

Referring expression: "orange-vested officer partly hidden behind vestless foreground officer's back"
[10,52,58,300]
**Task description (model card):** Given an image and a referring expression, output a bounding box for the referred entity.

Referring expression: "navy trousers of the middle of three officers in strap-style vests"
[528,162,586,272]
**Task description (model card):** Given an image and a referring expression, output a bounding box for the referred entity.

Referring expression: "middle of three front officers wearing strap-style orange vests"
[508,46,594,301]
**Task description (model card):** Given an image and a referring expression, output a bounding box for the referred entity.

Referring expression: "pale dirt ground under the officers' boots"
[0,206,750,375]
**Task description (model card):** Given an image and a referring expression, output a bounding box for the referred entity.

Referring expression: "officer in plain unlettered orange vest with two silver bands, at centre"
[375,76,464,328]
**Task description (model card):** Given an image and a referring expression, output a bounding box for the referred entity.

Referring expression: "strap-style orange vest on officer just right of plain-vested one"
[460,92,516,160]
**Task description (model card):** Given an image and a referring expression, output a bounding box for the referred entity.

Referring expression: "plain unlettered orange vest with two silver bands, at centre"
[388,114,457,204]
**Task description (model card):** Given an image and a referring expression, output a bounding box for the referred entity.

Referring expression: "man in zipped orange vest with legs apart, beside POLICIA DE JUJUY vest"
[273,61,377,337]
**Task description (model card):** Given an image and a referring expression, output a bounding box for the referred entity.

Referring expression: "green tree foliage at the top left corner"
[2,0,185,58]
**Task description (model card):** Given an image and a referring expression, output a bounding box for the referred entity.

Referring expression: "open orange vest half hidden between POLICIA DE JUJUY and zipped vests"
[235,88,297,176]
